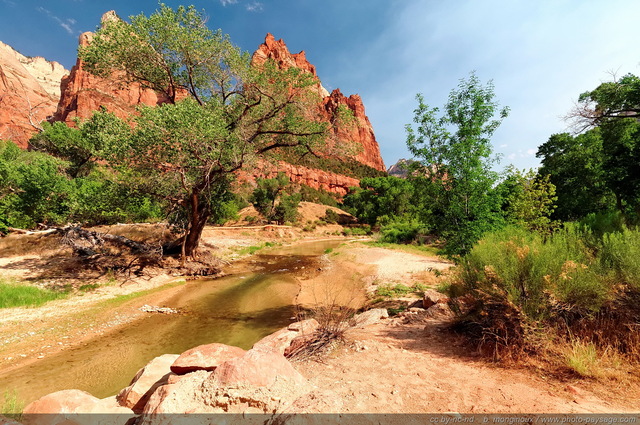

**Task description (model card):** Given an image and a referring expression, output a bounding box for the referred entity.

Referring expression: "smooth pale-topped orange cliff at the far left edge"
[0,42,68,148]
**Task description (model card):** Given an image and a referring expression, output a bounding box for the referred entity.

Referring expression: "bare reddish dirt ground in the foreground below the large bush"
[297,320,638,413]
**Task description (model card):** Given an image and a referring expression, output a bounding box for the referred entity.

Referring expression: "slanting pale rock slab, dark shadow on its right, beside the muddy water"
[116,354,179,413]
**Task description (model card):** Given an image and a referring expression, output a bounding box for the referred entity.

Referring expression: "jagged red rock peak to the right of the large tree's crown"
[252,34,386,171]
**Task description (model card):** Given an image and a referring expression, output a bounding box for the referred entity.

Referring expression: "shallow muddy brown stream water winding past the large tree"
[0,240,340,403]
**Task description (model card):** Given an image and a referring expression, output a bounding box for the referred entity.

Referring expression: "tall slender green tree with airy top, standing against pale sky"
[406,73,509,254]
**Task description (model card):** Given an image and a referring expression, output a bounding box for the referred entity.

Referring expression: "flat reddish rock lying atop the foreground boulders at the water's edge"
[171,343,245,375]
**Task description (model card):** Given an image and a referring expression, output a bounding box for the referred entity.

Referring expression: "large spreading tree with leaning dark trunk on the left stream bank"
[80,4,339,256]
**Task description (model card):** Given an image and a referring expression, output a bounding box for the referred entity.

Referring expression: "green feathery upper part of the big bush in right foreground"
[452,226,614,320]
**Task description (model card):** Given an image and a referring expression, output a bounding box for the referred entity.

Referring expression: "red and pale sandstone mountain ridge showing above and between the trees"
[0,12,386,195]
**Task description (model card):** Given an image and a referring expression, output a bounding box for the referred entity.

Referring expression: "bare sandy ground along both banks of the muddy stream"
[3,224,640,413]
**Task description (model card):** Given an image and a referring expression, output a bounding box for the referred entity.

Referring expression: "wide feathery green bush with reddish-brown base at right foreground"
[450,225,640,362]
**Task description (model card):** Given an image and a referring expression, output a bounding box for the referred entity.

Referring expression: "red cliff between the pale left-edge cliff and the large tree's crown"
[53,30,174,124]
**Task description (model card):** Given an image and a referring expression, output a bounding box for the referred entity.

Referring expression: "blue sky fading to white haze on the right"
[0,0,640,168]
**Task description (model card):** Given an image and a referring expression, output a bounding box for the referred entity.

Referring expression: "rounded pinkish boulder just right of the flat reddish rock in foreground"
[212,349,306,387]
